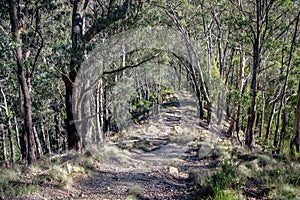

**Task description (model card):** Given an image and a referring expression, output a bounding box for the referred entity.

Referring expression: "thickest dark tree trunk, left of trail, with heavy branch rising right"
[63,0,138,150]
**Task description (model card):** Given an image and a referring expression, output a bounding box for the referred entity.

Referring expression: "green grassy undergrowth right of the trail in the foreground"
[191,145,300,200]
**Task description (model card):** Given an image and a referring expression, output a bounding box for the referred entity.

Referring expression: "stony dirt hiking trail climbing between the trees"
[19,91,225,200]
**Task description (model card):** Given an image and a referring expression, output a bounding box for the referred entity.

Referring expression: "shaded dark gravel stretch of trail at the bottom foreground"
[81,170,191,200]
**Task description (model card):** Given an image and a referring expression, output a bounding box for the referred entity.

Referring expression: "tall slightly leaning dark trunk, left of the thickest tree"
[9,0,35,165]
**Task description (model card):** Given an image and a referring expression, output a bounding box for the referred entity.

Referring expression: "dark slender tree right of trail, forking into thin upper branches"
[230,0,284,149]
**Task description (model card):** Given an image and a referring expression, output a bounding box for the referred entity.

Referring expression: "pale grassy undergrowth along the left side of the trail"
[0,145,134,199]
